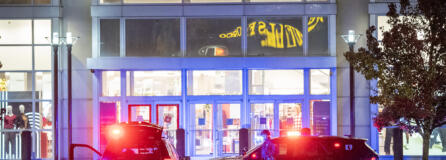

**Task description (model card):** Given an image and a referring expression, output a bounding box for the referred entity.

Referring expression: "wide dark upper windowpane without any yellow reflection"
[125,19,180,57]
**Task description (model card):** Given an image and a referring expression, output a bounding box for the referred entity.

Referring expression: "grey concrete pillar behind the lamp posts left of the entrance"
[59,0,93,159]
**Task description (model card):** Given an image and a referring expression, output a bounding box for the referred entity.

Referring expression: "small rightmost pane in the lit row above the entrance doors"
[310,69,330,95]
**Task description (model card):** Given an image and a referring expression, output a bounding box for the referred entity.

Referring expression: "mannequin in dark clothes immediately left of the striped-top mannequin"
[17,104,32,160]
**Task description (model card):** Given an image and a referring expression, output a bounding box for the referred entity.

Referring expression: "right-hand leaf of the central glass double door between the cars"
[216,103,241,155]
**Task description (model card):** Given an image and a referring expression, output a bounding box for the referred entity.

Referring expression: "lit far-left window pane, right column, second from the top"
[34,46,52,71]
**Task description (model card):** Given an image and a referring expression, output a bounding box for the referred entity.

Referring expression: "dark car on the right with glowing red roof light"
[214,136,378,160]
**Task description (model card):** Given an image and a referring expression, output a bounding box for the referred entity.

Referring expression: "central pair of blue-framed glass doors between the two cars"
[190,102,241,157]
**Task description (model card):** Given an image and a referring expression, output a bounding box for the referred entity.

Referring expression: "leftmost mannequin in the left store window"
[3,106,16,157]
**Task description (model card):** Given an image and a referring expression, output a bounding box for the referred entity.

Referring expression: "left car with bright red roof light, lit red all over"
[102,122,180,160]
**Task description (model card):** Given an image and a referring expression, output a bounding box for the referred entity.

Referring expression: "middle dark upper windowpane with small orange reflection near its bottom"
[187,19,242,57]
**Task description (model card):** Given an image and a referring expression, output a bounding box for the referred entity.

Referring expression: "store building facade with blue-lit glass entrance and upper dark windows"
[0,0,445,159]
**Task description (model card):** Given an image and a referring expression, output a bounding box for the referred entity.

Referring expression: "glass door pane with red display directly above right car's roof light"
[279,103,302,135]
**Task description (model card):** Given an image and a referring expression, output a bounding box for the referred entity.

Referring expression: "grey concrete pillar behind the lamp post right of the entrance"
[336,0,370,142]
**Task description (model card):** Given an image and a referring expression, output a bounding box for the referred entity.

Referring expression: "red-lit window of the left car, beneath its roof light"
[103,140,169,160]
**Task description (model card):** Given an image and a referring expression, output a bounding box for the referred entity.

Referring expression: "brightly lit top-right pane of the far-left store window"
[34,19,51,44]
